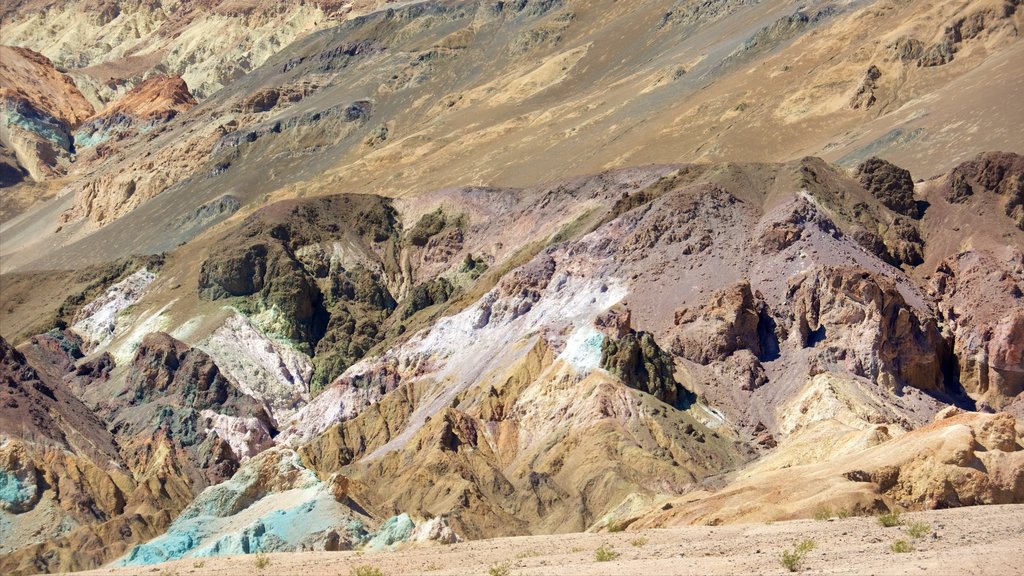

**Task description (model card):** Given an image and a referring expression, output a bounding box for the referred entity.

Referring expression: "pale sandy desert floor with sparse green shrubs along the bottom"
[74,505,1024,576]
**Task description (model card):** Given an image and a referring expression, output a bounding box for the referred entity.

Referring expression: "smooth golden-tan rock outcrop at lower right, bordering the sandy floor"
[622,413,1024,529]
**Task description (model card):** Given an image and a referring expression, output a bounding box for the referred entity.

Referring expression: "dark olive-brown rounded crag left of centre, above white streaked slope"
[193,195,401,388]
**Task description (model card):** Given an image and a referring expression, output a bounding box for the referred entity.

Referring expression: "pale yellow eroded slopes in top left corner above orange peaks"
[0,0,390,101]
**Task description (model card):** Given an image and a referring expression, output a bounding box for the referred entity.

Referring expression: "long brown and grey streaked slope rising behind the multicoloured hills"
[3,0,1022,270]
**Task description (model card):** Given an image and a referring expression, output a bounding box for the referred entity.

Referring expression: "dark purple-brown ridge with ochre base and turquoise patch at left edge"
[0,338,174,574]
